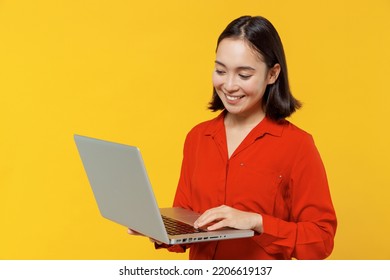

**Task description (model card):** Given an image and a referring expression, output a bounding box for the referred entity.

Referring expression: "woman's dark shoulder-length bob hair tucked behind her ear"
[208,16,301,121]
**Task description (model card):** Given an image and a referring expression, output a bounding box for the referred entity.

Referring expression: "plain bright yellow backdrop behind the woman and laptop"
[0,0,390,259]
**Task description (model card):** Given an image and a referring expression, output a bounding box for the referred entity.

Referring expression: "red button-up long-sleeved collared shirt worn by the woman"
[169,113,337,259]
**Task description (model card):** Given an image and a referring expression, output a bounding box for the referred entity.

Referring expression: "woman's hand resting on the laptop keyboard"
[194,205,263,233]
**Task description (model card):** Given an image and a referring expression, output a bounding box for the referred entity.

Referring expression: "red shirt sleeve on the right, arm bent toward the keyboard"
[255,137,337,259]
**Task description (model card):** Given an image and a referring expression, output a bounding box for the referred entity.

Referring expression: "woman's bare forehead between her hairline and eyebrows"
[216,38,265,65]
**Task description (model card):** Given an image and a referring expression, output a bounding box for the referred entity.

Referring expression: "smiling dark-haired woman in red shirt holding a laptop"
[130,16,337,259]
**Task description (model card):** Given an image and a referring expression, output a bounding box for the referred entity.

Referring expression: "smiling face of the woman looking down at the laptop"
[213,38,280,118]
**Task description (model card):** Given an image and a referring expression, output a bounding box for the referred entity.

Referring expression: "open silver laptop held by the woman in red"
[74,135,254,244]
